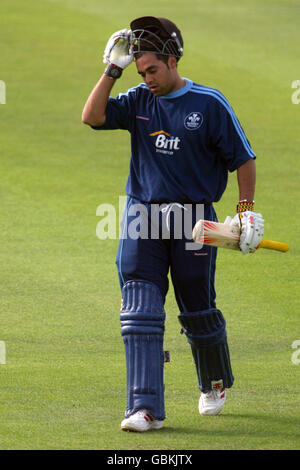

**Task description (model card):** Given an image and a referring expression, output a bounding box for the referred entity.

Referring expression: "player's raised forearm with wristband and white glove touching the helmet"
[82,29,133,127]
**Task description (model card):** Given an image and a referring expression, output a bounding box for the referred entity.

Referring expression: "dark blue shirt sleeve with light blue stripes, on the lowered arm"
[211,92,256,172]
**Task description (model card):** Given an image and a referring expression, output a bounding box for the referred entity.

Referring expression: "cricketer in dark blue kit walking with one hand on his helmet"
[82,16,264,432]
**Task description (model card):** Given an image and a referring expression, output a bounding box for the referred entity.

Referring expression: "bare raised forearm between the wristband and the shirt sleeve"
[81,74,116,127]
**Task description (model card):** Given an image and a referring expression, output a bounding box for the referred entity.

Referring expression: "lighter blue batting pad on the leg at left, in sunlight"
[120,280,165,420]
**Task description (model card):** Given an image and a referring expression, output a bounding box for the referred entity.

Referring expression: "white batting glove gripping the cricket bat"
[224,211,264,255]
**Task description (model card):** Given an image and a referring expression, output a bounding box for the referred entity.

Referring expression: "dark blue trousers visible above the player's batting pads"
[116,197,217,312]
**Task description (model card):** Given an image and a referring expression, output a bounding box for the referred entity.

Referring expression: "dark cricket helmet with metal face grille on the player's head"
[130,16,183,60]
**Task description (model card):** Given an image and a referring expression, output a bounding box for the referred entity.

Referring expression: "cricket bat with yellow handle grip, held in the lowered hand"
[193,219,290,252]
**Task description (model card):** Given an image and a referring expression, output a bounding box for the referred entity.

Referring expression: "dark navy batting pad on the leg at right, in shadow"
[178,309,234,393]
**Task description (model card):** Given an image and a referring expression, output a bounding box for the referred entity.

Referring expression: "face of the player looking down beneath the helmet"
[136,52,178,96]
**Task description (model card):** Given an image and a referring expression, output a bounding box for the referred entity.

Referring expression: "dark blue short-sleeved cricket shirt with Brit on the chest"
[93,78,256,203]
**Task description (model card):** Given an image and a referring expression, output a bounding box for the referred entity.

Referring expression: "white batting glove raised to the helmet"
[103,29,133,69]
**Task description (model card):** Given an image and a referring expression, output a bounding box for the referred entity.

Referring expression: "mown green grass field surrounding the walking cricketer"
[0,0,300,450]
